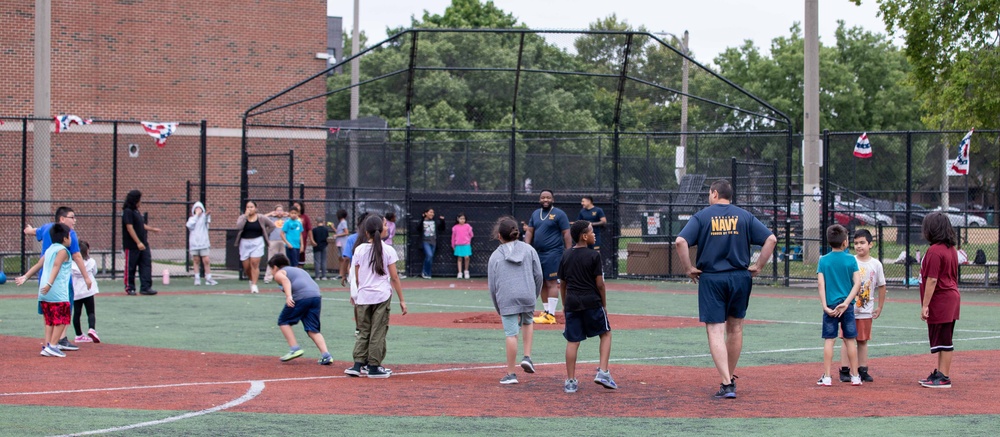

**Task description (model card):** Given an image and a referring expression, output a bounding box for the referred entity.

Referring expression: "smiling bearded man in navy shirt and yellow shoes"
[524,190,573,325]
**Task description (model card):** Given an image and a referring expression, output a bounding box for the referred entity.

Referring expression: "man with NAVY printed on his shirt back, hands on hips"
[675,180,778,398]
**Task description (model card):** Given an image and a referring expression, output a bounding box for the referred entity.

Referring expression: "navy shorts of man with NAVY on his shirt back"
[698,270,753,323]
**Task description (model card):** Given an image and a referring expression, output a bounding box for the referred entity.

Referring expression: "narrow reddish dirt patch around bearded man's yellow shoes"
[389,312,767,331]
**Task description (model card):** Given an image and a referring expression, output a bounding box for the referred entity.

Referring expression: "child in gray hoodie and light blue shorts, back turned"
[488,217,544,384]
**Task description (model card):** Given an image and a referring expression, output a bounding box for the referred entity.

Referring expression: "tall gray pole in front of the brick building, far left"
[33,0,52,225]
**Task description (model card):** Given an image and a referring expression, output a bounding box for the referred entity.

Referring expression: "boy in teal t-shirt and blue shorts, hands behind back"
[816,225,861,387]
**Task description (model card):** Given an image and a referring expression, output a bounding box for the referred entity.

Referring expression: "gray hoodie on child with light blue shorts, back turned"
[489,241,544,316]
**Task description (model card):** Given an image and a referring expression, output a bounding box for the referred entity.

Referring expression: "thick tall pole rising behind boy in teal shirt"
[802,0,830,264]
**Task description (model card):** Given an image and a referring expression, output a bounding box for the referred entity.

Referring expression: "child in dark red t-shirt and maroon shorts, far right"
[919,212,962,388]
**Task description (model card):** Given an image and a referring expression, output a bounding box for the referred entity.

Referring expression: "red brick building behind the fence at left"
[0,0,327,257]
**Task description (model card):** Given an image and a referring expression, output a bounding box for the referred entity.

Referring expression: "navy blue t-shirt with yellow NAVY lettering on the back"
[678,203,771,273]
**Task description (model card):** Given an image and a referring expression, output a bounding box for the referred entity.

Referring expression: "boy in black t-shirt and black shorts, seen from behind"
[559,220,618,393]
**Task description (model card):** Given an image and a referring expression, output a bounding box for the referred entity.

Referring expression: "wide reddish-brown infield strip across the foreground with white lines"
[0,336,1000,418]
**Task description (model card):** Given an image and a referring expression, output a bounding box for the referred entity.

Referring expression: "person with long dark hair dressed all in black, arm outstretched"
[122,190,160,296]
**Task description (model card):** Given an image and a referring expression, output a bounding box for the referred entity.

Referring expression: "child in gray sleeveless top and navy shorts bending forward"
[267,253,333,366]
